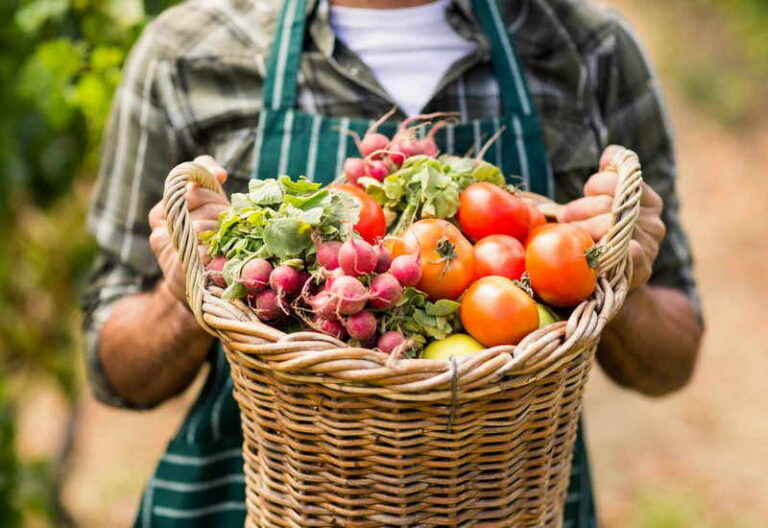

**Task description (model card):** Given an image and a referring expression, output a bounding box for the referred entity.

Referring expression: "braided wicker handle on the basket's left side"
[163,161,226,328]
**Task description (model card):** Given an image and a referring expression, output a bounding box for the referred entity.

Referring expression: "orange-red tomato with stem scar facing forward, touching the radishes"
[402,218,475,299]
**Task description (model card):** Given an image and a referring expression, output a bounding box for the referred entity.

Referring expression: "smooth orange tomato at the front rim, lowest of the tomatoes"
[459,277,539,347]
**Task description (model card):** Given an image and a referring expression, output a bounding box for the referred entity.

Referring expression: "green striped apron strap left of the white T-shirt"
[264,0,307,110]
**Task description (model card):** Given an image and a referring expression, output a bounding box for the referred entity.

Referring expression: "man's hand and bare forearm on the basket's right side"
[558,147,702,396]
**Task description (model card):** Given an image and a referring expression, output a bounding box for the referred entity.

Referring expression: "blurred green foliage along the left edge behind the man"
[0,0,175,528]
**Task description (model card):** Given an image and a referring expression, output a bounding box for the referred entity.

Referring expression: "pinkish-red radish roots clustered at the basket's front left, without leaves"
[208,238,421,353]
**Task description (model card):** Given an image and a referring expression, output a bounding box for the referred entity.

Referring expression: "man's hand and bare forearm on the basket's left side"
[98,156,229,407]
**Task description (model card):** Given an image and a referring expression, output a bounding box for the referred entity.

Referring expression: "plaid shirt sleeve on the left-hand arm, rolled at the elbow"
[82,25,184,408]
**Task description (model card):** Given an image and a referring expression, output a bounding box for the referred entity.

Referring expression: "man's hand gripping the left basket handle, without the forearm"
[149,156,229,303]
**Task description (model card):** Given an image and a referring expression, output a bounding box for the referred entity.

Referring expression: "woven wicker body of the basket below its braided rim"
[227,340,594,528]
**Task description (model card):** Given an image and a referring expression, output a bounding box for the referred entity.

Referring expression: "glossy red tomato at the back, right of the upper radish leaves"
[457,182,530,242]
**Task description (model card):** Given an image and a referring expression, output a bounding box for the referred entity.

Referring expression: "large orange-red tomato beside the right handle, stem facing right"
[525,224,597,307]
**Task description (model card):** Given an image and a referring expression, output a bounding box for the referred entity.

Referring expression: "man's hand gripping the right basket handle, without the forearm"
[558,147,666,290]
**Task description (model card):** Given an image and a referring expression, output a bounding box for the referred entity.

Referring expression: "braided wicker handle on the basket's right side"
[598,145,643,286]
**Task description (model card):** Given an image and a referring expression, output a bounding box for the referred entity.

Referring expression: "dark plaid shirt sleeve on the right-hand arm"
[598,19,701,315]
